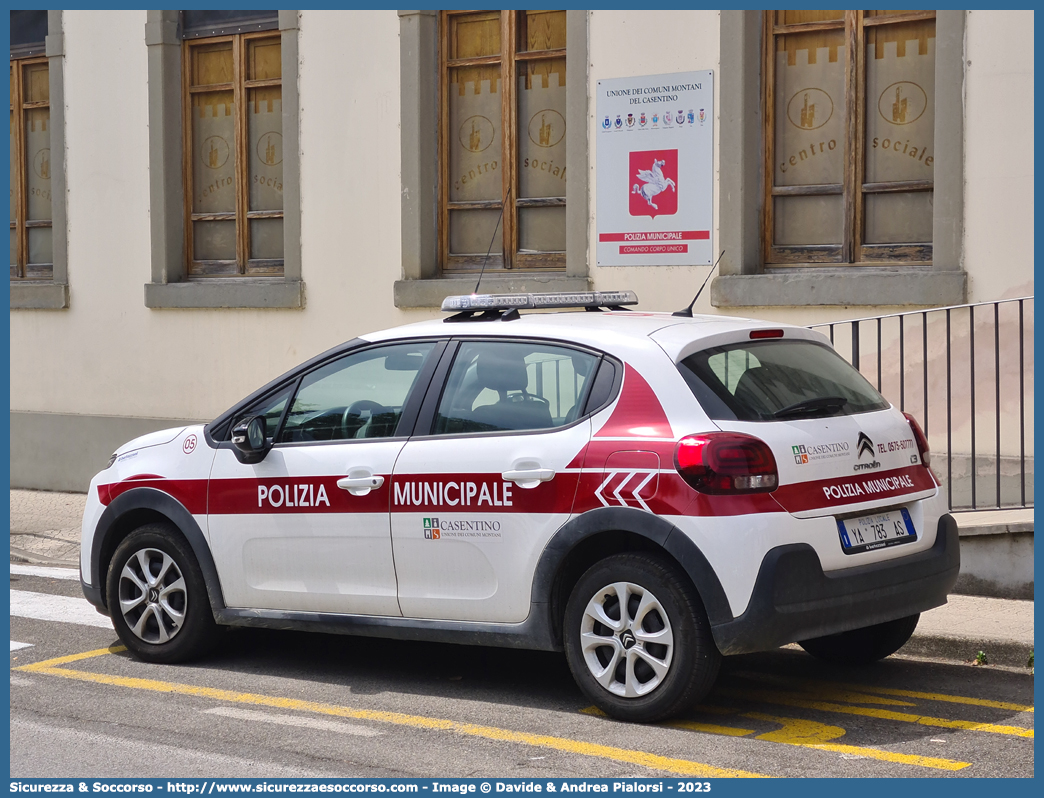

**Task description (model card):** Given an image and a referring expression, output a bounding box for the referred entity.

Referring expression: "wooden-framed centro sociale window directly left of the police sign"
[438,10,566,274]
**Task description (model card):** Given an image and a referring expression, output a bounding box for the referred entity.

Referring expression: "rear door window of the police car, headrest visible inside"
[434,341,599,435]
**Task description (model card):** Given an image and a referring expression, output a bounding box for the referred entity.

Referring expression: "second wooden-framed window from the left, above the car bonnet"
[182,31,283,277]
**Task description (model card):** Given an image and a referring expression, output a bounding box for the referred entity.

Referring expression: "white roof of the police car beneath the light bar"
[360,310,823,357]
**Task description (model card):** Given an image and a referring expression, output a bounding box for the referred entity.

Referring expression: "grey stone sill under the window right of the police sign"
[711,266,968,307]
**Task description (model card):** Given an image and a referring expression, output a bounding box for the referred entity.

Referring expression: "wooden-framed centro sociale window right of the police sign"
[762,10,935,265]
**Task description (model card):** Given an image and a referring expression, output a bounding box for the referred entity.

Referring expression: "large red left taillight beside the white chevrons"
[674,432,779,494]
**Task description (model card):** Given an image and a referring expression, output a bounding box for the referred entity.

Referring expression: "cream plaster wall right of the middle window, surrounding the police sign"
[588,10,1034,324]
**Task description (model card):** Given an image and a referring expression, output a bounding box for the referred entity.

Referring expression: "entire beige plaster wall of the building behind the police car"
[10,10,1034,426]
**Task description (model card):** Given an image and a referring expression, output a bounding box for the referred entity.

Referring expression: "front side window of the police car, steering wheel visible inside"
[279,342,435,443]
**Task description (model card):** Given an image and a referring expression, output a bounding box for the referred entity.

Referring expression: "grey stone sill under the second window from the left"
[145,280,305,308]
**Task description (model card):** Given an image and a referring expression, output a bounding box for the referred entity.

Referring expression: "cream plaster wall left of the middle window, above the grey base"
[10,10,430,419]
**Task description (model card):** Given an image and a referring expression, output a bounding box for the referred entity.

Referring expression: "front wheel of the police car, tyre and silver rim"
[105,523,219,662]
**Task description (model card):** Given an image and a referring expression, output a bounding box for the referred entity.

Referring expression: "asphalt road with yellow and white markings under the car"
[10,566,1034,779]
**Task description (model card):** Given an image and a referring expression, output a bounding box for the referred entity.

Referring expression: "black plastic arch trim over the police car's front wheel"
[85,488,224,612]
